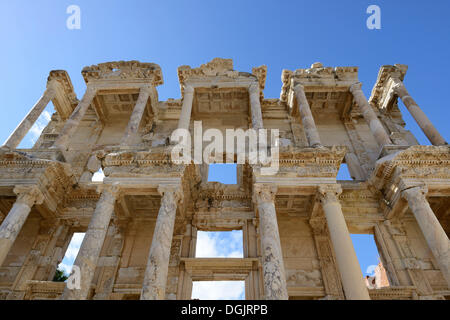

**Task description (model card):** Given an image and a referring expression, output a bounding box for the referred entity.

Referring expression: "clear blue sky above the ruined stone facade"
[0,0,450,296]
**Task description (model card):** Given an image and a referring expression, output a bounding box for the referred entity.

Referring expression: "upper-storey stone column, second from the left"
[54,85,97,151]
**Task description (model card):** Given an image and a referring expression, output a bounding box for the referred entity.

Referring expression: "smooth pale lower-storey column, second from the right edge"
[319,185,370,300]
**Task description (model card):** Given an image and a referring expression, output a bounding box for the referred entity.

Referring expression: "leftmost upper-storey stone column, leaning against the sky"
[4,82,56,149]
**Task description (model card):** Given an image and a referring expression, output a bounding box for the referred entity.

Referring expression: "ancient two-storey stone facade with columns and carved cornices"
[0,58,450,299]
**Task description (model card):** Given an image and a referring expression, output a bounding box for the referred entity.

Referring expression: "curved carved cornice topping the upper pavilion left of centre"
[81,60,164,86]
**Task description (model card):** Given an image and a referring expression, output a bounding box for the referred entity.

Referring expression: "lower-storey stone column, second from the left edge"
[61,185,120,300]
